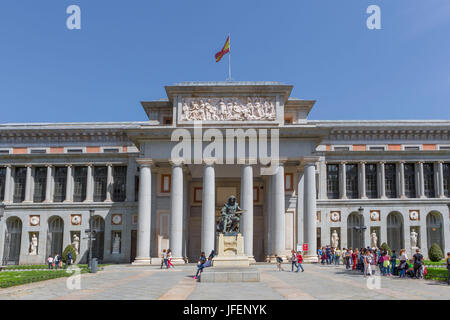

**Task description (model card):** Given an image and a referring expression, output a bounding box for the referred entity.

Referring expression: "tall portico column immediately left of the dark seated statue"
[201,159,216,255]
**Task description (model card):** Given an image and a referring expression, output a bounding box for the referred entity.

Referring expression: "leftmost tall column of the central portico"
[133,159,153,264]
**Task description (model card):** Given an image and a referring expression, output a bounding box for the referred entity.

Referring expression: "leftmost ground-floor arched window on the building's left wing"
[3,217,22,265]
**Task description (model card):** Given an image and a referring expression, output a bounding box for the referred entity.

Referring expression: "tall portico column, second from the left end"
[169,162,184,264]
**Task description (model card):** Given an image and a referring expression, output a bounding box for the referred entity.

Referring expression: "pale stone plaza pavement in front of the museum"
[0,264,450,300]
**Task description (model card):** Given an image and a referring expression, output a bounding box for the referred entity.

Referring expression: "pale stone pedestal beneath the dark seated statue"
[213,233,249,267]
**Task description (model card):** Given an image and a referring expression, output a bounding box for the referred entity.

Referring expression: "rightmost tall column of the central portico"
[303,162,316,262]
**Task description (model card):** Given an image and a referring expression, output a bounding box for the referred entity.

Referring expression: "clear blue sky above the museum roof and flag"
[0,0,450,123]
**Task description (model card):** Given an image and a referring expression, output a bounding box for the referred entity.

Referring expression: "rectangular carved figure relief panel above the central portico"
[181,97,277,121]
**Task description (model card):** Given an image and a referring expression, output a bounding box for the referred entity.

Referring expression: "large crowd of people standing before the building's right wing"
[317,246,427,279]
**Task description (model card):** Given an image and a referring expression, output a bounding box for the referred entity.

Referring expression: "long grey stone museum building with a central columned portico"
[0,82,450,265]
